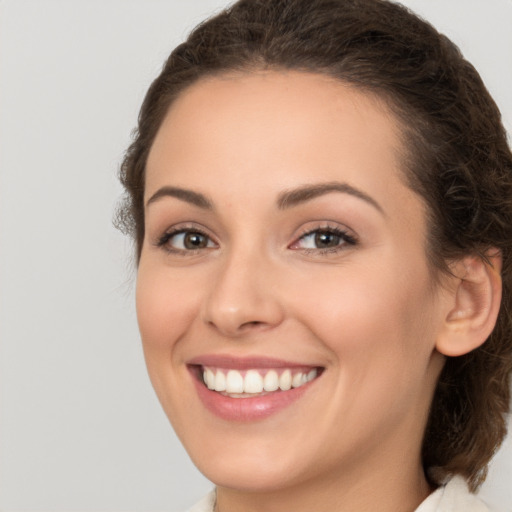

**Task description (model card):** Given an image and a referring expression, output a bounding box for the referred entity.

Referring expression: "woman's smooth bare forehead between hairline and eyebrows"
[146,71,418,219]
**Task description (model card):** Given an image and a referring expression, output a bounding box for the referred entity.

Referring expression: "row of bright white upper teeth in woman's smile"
[203,368,317,394]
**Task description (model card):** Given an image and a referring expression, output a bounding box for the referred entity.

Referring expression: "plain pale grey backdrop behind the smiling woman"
[0,0,512,512]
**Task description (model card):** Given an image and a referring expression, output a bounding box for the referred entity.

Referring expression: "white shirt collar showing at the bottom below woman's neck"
[188,476,491,512]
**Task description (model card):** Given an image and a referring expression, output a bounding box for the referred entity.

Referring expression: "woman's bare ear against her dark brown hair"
[436,249,501,357]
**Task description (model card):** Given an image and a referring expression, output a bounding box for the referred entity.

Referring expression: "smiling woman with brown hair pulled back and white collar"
[116,0,512,512]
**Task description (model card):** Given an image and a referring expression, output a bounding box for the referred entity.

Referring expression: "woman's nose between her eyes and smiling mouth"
[202,247,284,337]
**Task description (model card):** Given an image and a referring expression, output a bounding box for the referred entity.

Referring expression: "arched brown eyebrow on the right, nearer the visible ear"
[277,181,385,215]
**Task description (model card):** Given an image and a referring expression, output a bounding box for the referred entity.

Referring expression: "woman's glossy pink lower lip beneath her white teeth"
[193,370,316,422]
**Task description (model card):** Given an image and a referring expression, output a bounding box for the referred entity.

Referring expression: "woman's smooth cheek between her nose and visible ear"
[295,255,436,371]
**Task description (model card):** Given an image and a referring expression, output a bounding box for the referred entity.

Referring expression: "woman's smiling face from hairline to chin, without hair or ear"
[137,72,448,490]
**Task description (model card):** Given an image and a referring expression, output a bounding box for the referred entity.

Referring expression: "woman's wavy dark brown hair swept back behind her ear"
[118,0,512,490]
